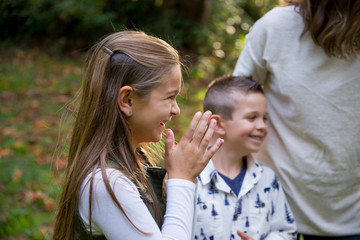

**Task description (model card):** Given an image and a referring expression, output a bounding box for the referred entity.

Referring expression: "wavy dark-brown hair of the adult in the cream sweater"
[284,0,360,59]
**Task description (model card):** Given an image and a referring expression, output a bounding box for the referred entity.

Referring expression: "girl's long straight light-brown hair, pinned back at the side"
[53,31,181,239]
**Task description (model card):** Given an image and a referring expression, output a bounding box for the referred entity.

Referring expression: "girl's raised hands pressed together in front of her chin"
[165,111,223,181]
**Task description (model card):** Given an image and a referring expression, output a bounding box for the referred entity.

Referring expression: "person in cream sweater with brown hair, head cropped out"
[234,0,360,240]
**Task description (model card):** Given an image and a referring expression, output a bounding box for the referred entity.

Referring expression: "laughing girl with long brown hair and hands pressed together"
[54,31,222,240]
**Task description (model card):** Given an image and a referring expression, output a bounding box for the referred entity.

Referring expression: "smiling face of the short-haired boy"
[223,92,268,156]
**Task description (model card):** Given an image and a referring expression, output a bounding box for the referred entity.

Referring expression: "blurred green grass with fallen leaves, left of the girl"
[0,47,81,239]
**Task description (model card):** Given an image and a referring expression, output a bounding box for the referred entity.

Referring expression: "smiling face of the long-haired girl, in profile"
[129,66,181,147]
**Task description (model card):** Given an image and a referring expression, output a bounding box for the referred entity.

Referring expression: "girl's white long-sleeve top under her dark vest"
[79,168,195,240]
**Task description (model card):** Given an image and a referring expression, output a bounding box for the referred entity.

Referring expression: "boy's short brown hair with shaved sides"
[203,75,264,120]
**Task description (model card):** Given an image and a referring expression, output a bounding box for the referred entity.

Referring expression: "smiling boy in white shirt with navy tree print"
[192,76,296,240]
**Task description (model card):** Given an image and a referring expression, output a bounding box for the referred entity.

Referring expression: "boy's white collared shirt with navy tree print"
[192,156,296,240]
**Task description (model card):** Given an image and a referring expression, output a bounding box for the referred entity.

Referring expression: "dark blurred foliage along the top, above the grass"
[0,0,277,61]
